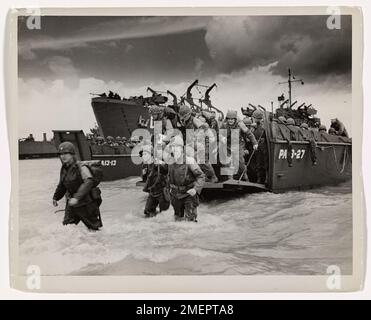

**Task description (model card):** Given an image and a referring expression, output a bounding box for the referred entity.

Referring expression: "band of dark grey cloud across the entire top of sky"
[18,16,352,84]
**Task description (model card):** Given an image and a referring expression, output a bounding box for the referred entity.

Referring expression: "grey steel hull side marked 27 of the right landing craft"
[269,141,352,192]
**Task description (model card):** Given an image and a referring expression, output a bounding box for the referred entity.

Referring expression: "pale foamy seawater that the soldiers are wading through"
[19,159,352,275]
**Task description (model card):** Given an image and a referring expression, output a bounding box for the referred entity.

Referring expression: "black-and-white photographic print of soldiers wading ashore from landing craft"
[7,8,368,290]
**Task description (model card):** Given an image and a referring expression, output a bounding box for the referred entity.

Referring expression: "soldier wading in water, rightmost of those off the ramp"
[169,135,205,222]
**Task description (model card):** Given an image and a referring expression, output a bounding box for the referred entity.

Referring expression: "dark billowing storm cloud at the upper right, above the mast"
[205,16,352,81]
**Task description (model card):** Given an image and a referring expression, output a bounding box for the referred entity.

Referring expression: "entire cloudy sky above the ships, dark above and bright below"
[18,16,352,138]
